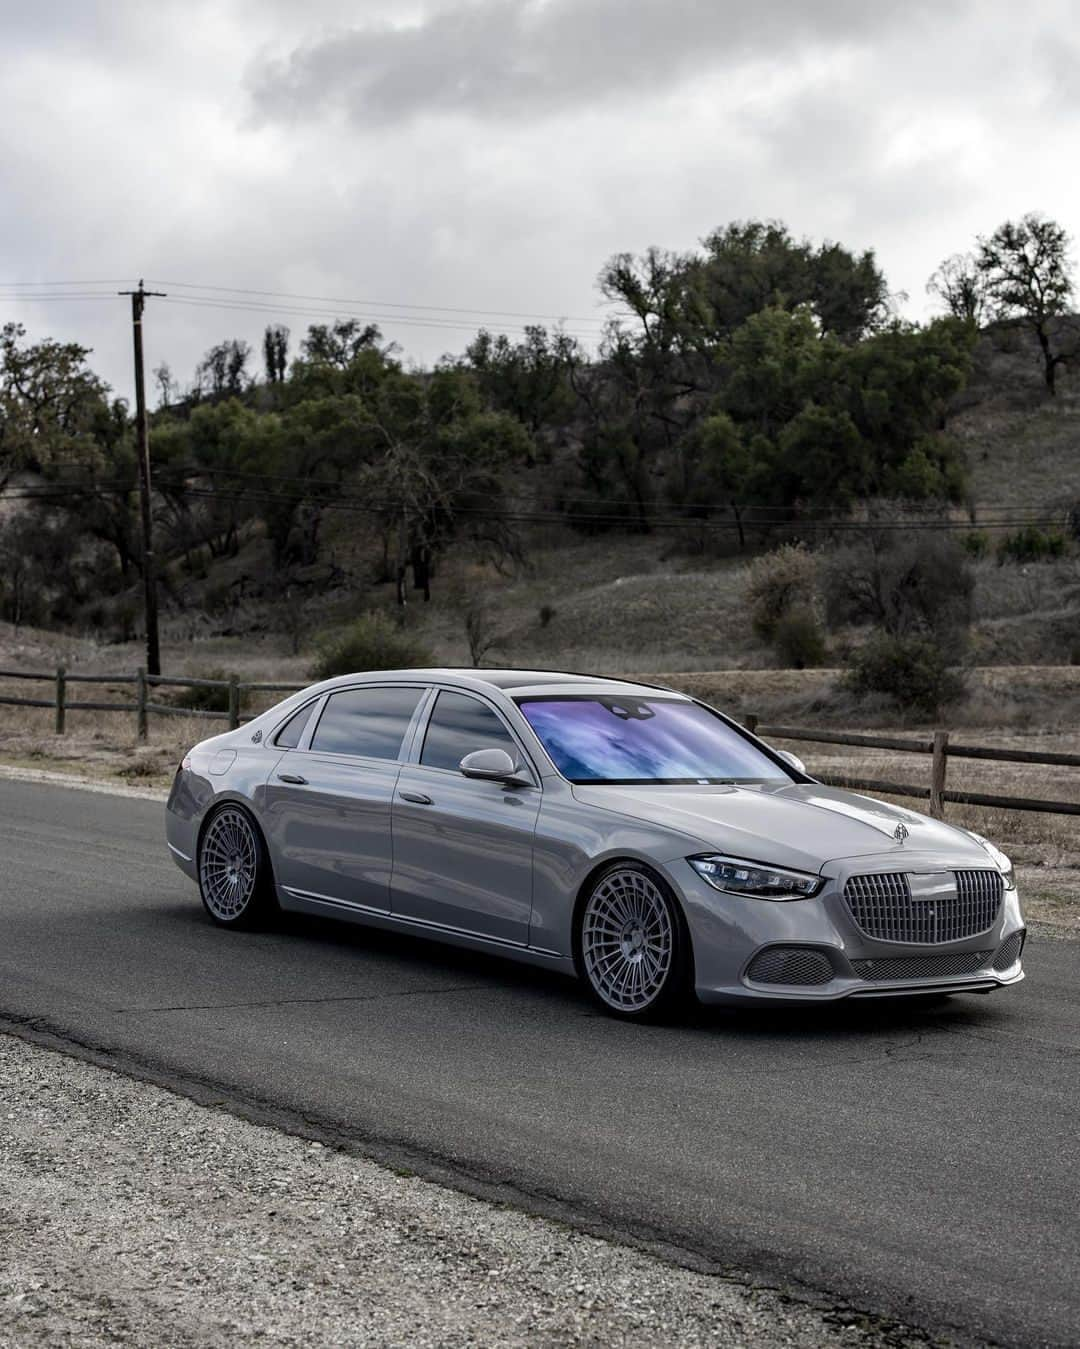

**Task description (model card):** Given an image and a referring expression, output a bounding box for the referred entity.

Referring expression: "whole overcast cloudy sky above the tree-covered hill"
[0,0,1080,394]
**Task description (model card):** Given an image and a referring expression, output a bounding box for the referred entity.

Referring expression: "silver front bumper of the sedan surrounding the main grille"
[669,853,1025,1006]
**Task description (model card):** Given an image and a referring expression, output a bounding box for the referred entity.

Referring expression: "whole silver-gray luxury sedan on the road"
[167,669,1025,1018]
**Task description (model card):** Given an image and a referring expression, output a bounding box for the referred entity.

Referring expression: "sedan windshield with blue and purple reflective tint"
[516,693,791,785]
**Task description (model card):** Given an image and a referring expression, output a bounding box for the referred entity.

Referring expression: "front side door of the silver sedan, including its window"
[391,688,541,946]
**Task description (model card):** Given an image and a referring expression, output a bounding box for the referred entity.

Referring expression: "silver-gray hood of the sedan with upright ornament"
[573,782,990,871]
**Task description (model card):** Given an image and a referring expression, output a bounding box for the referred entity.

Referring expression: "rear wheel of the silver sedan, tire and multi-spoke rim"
[198,803,278,928]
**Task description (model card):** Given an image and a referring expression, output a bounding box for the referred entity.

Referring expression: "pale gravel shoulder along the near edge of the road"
[0,1036,926,1349]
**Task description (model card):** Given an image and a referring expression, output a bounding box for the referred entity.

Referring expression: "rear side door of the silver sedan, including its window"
[266,684,425,913]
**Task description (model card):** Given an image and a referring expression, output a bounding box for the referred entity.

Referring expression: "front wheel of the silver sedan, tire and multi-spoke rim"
[576,862,692,1021]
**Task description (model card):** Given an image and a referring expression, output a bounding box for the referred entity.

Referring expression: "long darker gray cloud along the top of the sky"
[249,0,925,123]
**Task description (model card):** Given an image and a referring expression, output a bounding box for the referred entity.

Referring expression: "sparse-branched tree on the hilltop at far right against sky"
[976,212,1076,394]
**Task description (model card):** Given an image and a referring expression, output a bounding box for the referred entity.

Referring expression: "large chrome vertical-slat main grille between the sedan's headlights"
[844,871,1004,946]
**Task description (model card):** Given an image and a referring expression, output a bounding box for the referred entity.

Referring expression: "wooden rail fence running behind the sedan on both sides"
[0,665,1080,819]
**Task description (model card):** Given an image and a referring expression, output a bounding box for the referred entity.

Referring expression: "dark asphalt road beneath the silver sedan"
[0,781,1080,1345]
